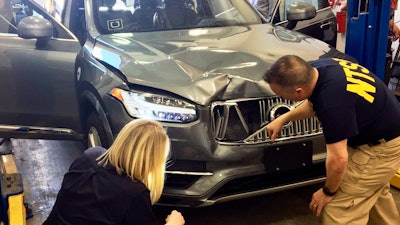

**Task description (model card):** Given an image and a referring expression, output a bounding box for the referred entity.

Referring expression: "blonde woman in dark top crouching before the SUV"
[43,119,185,225]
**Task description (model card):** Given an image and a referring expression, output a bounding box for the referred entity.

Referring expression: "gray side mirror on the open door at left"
[17,16,53,41]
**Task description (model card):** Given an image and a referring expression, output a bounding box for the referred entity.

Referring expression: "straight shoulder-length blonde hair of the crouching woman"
[97,119,170,204]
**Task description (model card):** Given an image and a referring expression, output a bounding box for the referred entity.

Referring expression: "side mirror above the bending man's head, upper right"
[286,2,317,29]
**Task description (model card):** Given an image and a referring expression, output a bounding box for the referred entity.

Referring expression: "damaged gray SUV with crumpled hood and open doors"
[0,0,352,207]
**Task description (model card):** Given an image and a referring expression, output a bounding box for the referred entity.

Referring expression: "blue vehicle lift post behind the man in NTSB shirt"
[345,0,391,80]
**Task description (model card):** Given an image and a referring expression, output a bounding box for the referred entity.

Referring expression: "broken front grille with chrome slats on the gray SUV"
[211,97,322,144]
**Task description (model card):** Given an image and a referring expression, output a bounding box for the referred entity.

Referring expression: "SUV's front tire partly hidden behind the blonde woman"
[84,112,110,148]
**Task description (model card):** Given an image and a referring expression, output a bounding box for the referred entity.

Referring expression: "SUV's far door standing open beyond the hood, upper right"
[272,0,337,47]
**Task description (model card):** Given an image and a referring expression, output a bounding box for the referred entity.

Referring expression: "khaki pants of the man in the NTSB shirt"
[322,137,400,225]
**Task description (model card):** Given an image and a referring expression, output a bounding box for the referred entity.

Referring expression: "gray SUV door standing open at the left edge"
[0,0,81,139]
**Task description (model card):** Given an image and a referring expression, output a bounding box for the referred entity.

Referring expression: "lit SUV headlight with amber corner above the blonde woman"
[110,88,197,123]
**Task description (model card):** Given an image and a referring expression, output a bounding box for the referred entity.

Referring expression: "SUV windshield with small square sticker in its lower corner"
[93,0,262,34]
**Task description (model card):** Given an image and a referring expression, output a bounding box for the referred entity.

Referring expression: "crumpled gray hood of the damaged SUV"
[93,24,337,105]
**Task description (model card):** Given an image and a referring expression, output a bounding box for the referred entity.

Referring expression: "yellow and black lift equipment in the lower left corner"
[0,138,32,225]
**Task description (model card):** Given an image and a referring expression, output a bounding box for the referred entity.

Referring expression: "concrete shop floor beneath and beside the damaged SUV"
[0,139,400,225]
